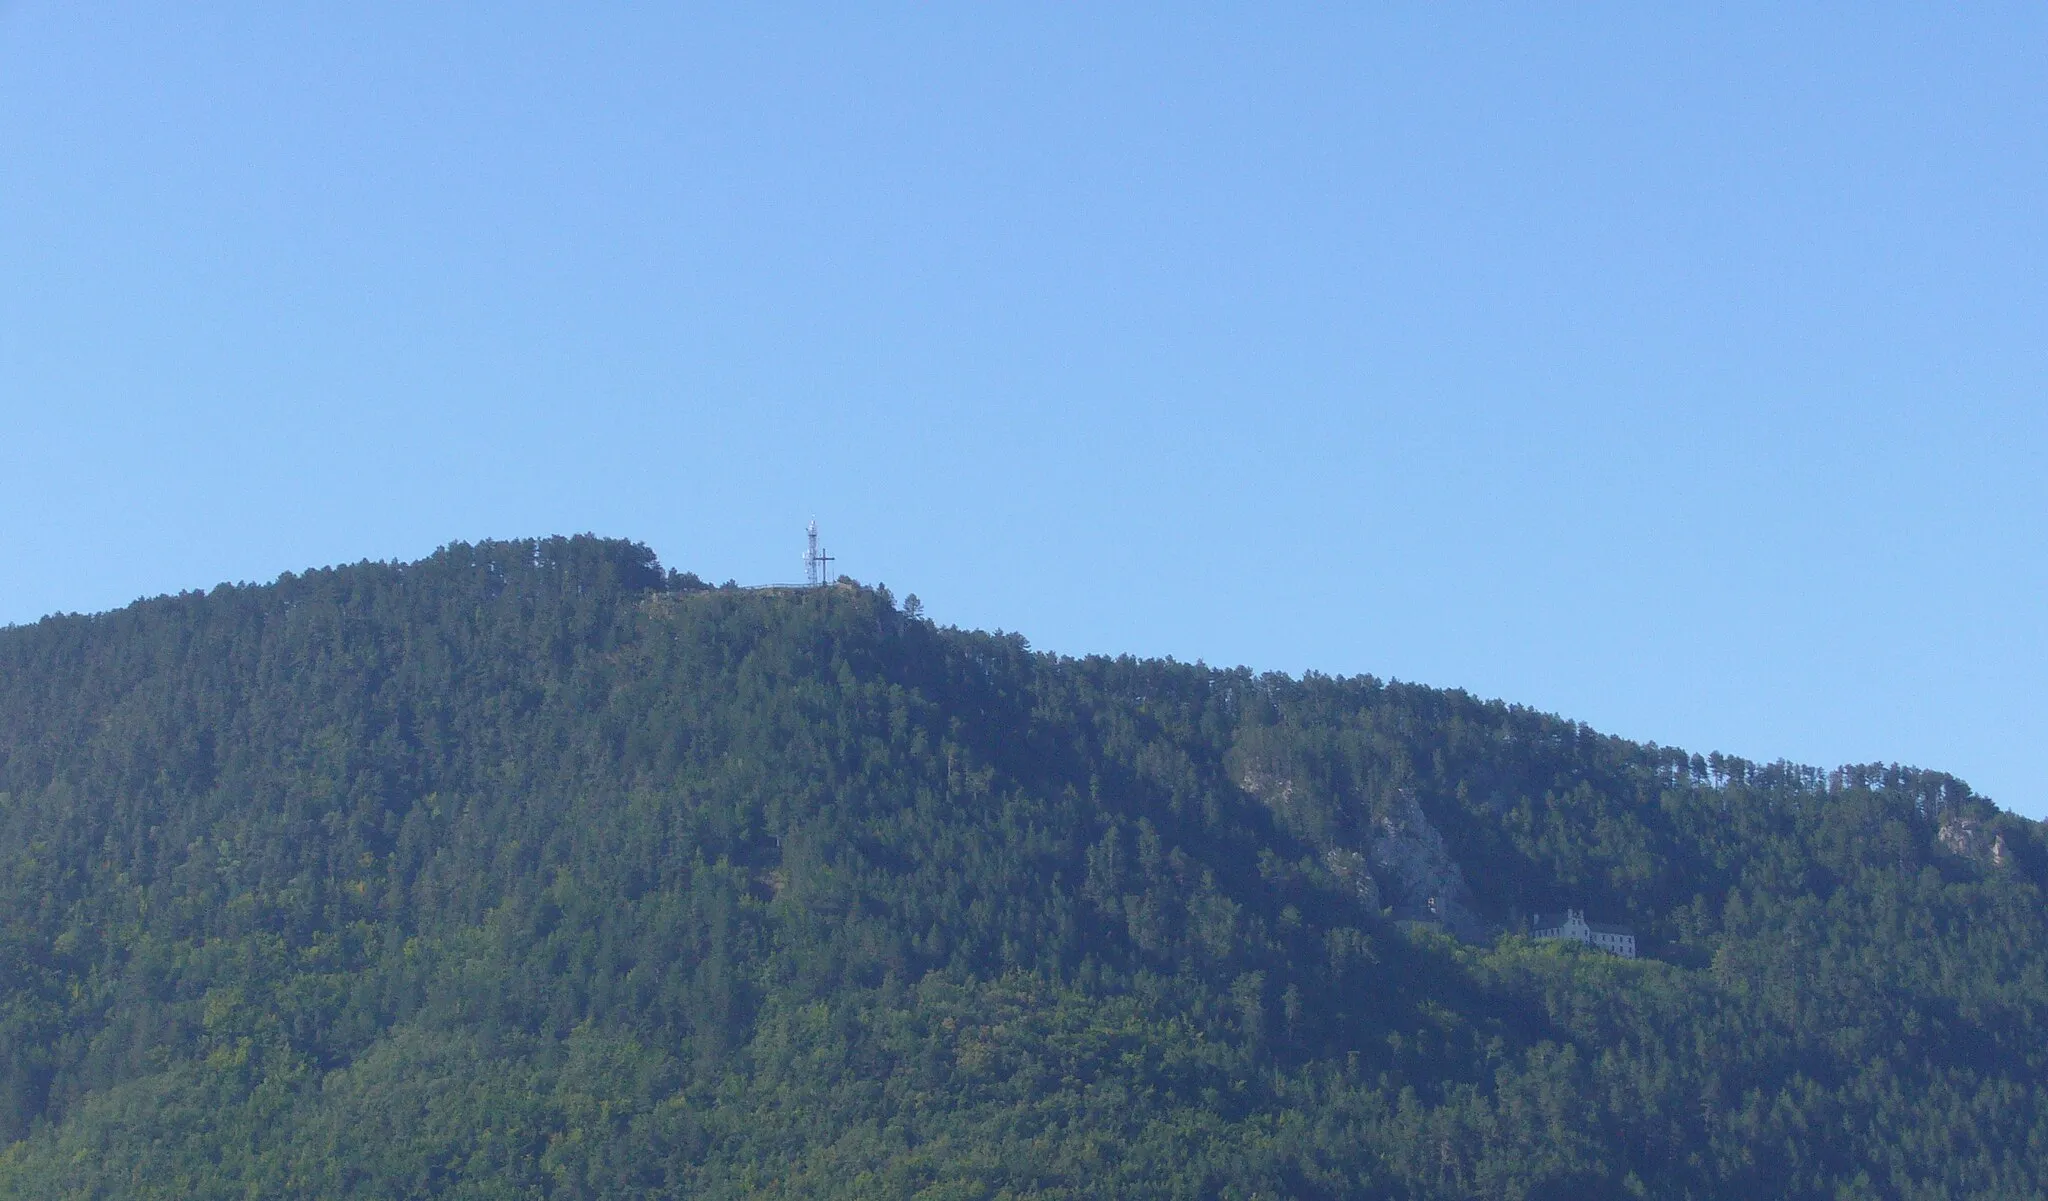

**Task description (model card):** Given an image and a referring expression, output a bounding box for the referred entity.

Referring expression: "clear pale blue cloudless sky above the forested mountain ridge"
[0,2,2048,816]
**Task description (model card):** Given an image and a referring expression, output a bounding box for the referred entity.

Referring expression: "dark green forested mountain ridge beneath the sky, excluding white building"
[0,537,2048,1201]
